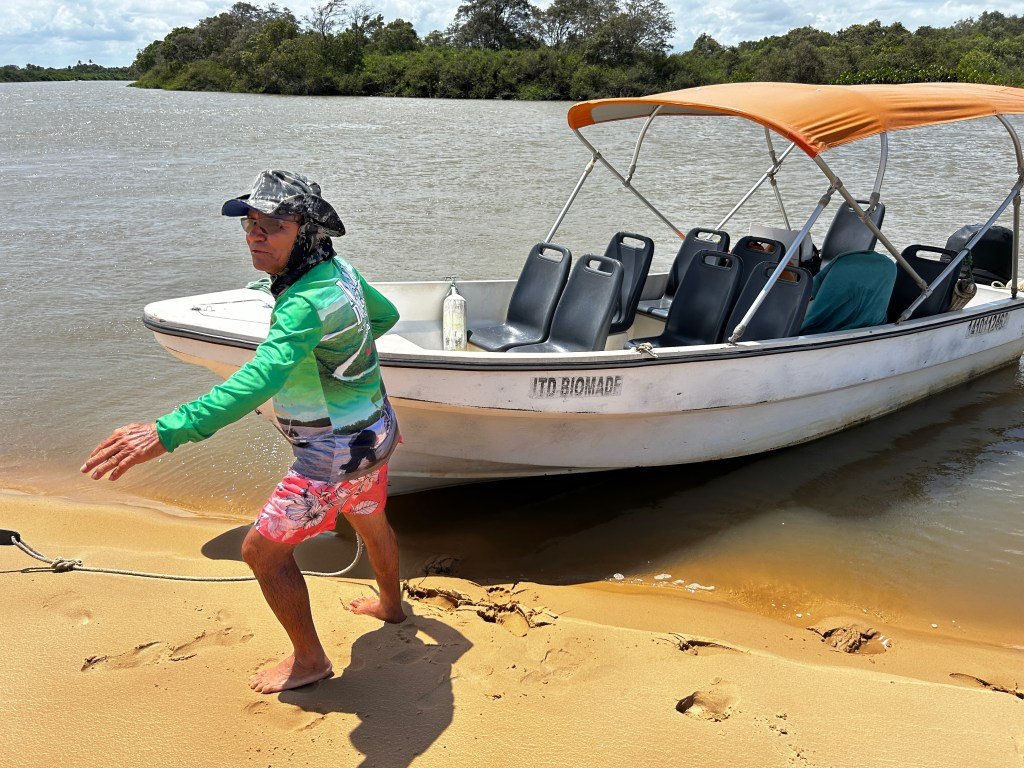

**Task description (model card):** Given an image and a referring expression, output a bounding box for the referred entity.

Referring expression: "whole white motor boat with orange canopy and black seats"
[144,83,1024,493]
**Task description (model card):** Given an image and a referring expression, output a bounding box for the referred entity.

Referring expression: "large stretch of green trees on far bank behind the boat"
[9,0,1024,100]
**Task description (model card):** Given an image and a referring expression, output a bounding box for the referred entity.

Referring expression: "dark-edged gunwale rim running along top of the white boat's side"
[142,296,1024,372]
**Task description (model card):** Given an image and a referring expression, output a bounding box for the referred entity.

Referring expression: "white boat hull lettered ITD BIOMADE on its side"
[147,286,1024,493]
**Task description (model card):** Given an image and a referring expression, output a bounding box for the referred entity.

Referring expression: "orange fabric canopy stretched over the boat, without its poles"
[568,83,1024,158]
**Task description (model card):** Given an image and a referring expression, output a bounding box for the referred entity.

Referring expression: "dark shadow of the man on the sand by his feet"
[280,608,473,768]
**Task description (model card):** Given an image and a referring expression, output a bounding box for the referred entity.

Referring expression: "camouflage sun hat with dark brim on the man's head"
[220,171,345,237]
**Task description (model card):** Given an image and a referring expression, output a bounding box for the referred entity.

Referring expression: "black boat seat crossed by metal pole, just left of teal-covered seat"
[723,261,814,341]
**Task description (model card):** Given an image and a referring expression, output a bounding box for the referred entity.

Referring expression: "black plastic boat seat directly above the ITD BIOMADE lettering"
[509,254,623,353]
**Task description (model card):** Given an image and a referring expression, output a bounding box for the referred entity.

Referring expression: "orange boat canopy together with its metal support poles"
[547,83,1024,343]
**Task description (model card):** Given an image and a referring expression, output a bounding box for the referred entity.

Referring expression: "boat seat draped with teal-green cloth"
[800,251,897,334]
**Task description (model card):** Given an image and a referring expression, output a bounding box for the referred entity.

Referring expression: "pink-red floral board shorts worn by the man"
[254,464,387,544]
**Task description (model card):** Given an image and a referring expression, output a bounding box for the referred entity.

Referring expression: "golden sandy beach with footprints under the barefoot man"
[0,493,1024,768]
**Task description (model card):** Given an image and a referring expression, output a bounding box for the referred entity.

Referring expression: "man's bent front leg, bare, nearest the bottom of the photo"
[242,528,333,693]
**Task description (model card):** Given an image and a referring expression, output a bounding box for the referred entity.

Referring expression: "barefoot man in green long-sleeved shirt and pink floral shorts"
[82,171,406,693]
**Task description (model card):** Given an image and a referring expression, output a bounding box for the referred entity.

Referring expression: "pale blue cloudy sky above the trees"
[0,0,1007,67]
